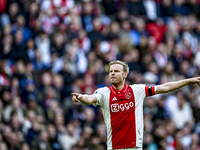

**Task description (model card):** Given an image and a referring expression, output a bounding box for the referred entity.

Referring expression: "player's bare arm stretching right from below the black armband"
[155,77,200,94]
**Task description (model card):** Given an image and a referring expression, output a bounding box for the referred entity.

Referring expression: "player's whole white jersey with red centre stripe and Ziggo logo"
[94,84,155,150]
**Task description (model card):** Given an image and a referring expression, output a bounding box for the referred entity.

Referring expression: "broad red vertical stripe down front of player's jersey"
[110,86,136,149]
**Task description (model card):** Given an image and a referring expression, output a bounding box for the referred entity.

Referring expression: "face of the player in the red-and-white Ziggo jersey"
[109,64,126,85]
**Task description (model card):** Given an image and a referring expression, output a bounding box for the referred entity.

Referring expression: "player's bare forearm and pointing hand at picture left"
[72,93,97,105]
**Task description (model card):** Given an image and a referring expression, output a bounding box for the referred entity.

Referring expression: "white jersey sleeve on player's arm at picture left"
[93,87,108,106]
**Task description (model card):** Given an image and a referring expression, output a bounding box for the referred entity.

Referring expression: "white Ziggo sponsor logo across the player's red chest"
[111,102,134,112]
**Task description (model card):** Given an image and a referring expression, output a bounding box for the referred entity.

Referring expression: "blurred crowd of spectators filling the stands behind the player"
[0,0,200,150]
